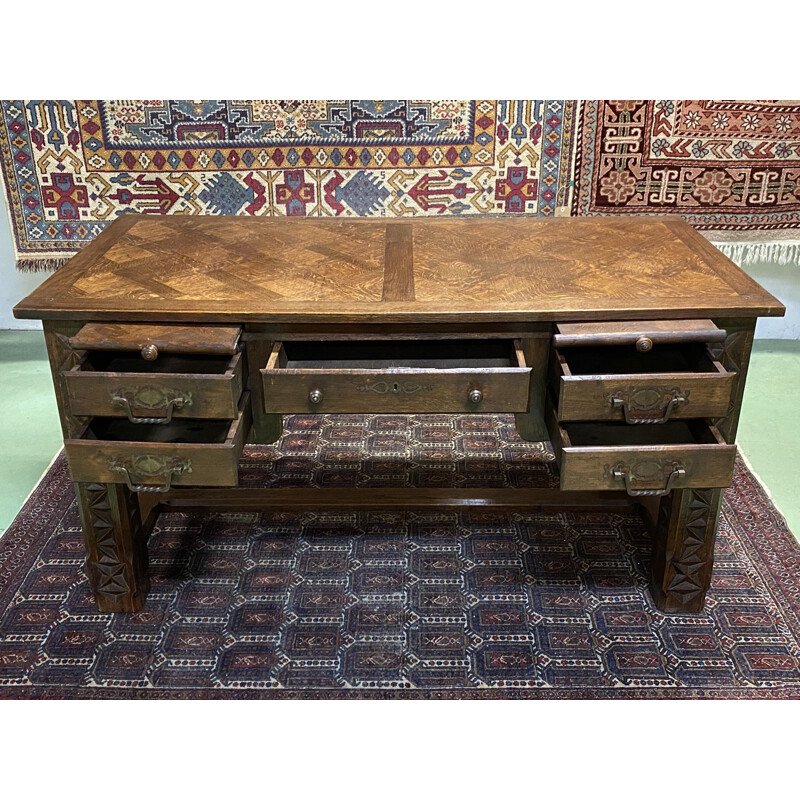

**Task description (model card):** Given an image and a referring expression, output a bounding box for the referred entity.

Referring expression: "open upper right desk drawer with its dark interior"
[550,342,735,424]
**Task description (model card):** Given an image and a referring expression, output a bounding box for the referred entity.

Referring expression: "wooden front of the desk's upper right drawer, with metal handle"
[550,349,735,424]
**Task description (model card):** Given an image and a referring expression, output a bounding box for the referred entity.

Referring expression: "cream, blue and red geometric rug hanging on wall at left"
[0,100,577,269]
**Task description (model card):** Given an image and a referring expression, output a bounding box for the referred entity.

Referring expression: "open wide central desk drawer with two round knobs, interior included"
[261,339,530,414]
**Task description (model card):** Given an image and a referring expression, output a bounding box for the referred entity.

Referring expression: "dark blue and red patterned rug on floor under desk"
[0,415,800,699]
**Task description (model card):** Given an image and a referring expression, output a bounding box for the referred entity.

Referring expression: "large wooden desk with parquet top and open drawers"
[15,215,784,612]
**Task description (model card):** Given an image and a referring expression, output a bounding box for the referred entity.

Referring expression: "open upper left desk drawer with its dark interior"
[63,350,243,424]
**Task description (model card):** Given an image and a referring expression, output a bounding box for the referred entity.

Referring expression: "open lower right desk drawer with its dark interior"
[547,405,736,496]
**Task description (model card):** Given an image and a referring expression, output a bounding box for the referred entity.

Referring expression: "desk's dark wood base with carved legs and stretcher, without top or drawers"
[34,319,754,613]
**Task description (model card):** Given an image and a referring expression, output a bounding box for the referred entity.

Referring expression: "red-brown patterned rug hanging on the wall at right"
[572,100,800,231]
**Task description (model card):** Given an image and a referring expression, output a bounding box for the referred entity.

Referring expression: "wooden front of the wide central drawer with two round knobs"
[261,344,530,414]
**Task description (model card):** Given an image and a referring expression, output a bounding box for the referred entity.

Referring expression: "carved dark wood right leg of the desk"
[650,320,755,614]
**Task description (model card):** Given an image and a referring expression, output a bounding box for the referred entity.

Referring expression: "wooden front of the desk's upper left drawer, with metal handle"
[63,353,243,423]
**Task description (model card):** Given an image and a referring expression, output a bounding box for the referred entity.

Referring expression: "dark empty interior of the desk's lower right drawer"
[561,419,724,447]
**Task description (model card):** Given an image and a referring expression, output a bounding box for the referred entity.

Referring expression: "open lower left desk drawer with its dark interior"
[64,392,251,492]
